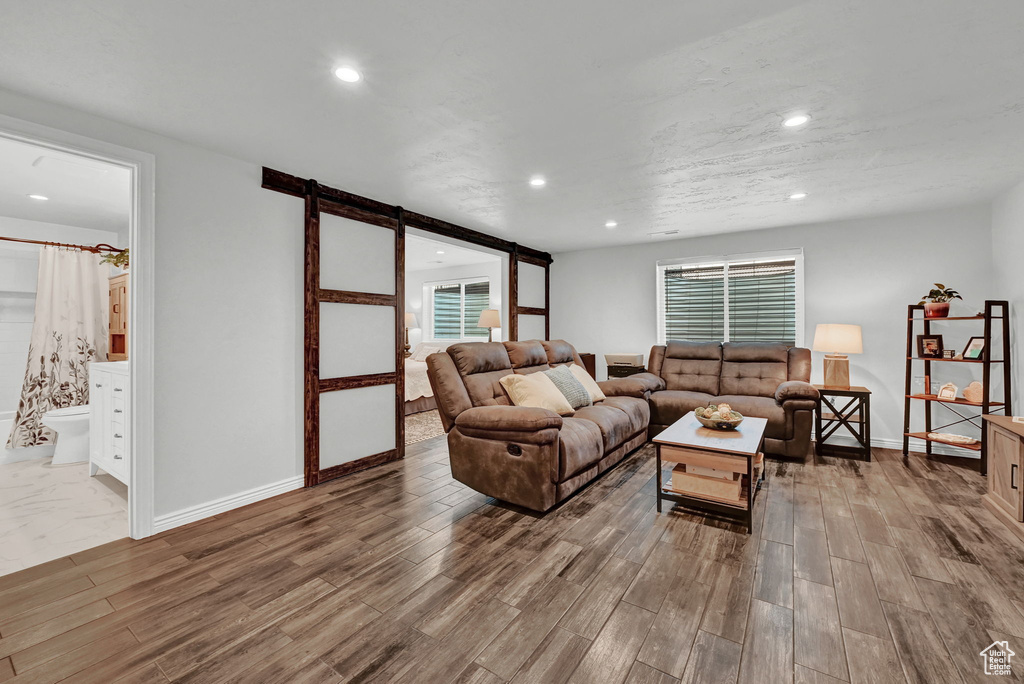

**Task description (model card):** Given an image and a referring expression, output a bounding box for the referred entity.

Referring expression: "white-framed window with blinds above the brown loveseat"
[657,250,804,346]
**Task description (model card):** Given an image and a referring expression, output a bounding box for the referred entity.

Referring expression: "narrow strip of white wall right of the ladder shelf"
[992,182,1024,416]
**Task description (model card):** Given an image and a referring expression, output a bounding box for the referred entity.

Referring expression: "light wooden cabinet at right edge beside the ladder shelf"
[983,416,1024,539]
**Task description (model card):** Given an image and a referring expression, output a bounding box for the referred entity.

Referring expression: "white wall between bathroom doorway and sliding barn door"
[0,90,303,517]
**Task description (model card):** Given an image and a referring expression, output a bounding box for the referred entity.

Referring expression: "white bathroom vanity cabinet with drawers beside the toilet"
[89,361,131,484]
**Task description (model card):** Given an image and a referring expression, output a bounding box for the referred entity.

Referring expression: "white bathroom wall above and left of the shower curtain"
[0,216,118,413]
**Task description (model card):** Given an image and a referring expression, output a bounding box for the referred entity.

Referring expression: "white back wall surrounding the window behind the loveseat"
[551,205,993,454]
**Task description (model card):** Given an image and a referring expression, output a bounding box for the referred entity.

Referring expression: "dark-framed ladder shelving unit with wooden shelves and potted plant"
[903,300,1013,475]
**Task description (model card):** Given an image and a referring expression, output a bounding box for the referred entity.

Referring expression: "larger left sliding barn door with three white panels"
[305,181,406,486]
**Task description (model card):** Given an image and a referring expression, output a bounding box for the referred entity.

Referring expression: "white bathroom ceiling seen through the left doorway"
[0,137,131,237]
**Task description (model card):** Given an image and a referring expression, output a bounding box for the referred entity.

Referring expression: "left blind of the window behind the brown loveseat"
[665,264,725,342]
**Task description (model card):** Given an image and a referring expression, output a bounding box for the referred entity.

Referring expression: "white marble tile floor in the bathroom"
[0,459,128,575]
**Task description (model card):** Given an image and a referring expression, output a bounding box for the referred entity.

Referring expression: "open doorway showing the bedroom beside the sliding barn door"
[404,228,509,445]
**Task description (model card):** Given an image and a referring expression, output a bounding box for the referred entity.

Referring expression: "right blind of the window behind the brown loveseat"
[728,259,797,346]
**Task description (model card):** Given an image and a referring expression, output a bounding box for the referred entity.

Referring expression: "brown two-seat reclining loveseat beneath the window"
[651,340,818,458]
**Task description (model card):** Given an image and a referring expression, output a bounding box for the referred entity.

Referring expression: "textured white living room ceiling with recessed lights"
[0,0,1024,251]
